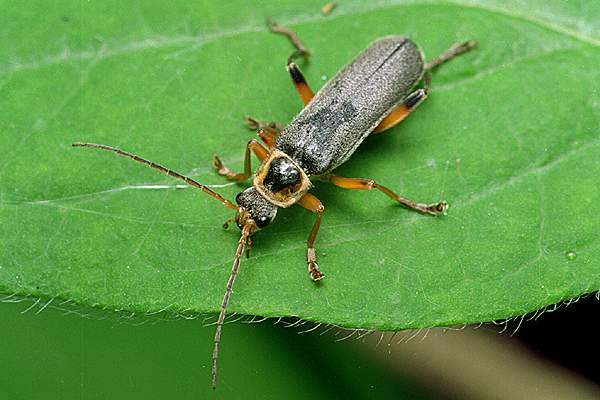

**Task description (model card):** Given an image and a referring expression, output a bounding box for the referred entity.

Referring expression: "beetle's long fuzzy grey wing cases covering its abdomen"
[275,36,423,175]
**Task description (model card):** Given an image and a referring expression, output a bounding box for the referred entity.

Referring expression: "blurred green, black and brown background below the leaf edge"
[0,296,600,399]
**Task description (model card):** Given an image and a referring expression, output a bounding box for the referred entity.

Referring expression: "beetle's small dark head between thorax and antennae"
[235,187,277,229]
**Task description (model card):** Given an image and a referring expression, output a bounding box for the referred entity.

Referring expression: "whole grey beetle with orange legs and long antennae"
[73,21,476,388]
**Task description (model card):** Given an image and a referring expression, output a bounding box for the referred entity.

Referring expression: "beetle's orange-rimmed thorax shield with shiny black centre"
[254,150,310,207]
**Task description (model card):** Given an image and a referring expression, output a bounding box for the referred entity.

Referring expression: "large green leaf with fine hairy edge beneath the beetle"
[0,0,600,330]
